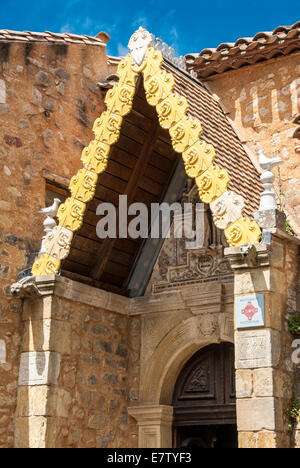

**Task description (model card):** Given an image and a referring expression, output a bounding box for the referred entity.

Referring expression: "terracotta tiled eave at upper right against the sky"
[186,21,300,78]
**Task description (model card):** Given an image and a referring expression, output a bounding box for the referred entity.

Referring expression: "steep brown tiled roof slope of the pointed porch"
[163,61,262,216]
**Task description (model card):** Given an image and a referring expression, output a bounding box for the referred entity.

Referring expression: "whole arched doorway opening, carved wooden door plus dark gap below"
[173,343,238,448]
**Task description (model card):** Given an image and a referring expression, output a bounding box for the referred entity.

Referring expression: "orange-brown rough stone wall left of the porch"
[0,42,111,447]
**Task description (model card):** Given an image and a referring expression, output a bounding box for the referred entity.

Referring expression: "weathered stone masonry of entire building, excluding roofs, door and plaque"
[0,25,300,448]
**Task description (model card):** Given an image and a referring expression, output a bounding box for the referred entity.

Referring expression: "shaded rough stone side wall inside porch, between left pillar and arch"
[55,299,140,448]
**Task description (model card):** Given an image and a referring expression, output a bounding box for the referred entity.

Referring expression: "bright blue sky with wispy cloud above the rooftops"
[0,0,300,55]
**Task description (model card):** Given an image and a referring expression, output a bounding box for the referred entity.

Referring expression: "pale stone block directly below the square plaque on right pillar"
[235,329,281,369]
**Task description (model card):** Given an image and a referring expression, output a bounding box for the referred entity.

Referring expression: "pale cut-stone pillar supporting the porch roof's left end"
[12,275,71,448]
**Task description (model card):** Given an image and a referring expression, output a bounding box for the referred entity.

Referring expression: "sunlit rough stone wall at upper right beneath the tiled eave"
[206,53,300,235]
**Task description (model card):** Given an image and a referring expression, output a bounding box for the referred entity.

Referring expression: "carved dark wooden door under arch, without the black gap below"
[173,343,236,427]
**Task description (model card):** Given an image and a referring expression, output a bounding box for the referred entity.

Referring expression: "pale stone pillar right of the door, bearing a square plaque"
[225,221,299,448]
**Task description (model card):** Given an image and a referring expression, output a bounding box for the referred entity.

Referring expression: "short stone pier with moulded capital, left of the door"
[128,405,173,448]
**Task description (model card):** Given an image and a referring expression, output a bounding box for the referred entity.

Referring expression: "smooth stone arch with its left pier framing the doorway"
[128,313,233,448]
